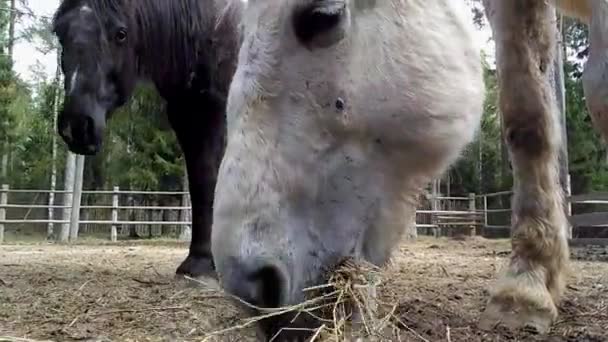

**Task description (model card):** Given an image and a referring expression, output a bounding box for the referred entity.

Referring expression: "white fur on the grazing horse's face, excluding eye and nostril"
[212,0,484,304]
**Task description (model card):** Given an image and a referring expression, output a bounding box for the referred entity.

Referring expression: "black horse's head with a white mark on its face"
[53,0,136,155]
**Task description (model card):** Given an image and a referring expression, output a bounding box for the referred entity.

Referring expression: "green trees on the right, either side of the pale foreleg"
[444,16,608,198]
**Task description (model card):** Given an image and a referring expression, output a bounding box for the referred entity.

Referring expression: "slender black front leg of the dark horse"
[169,100,226,278]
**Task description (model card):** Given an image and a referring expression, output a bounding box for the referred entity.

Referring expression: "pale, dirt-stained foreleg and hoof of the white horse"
[480,0,569,333]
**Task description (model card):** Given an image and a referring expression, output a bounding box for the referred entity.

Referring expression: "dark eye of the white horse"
[293,0,346,47]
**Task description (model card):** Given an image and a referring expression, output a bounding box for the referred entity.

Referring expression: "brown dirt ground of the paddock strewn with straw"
[0,238,608,342]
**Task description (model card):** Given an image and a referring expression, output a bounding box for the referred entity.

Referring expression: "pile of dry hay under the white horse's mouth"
[197,259,416,342]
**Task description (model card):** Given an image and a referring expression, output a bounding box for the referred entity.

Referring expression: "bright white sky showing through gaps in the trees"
[14,0,494,81]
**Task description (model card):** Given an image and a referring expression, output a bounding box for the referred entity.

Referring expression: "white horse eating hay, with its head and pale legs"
[212,0,608,338]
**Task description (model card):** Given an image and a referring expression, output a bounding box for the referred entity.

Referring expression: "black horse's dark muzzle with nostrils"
[57,98,106,155]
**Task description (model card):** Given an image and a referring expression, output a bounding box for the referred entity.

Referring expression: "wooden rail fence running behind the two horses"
[0,185,608,243]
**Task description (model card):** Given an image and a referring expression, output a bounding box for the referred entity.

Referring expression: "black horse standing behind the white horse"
[53,0,244,276]
